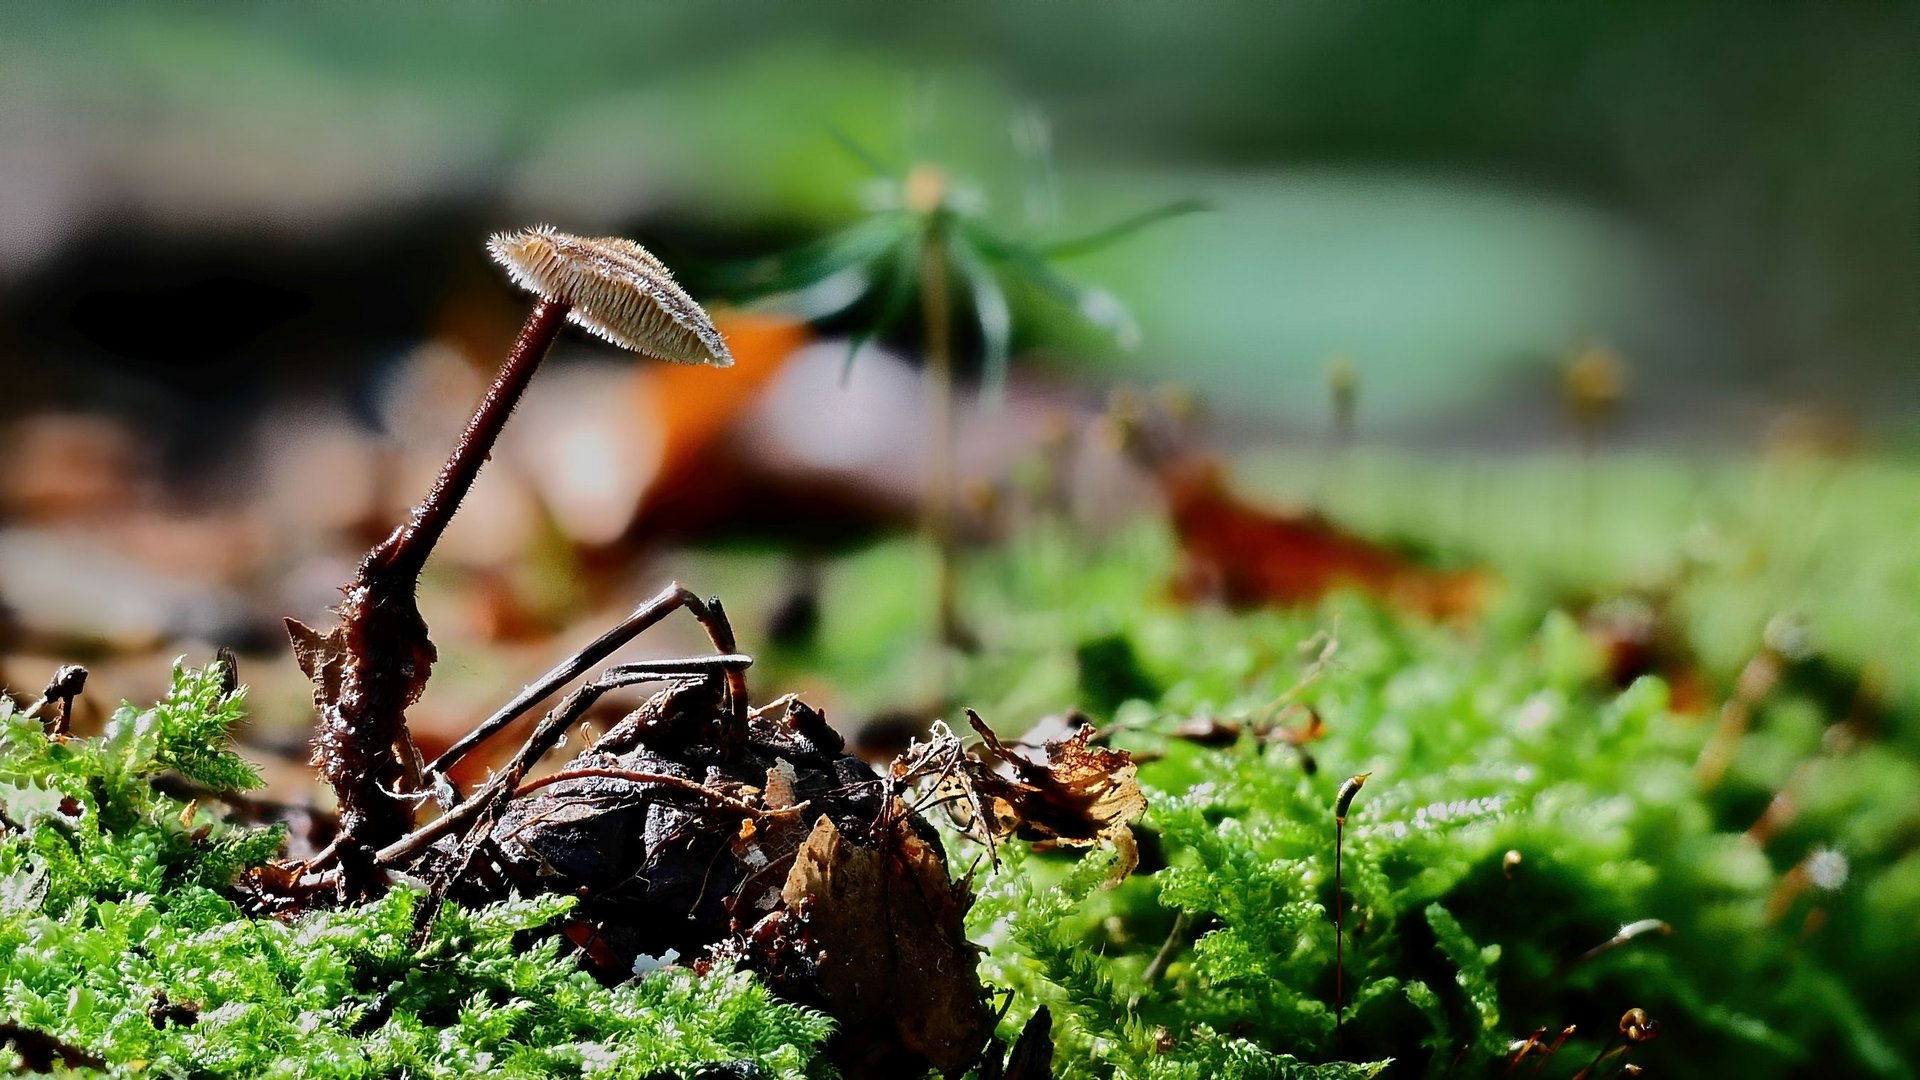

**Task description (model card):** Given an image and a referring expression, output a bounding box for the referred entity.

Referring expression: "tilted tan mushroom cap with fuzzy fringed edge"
[486,225,733,367]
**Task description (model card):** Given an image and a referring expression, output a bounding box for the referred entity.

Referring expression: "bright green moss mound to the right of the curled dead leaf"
[940,518,1920,1076]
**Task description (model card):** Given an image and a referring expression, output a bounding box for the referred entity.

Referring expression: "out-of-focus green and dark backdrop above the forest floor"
[0,2,1920,432]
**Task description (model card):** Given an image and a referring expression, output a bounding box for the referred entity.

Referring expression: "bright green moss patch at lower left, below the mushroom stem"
[0,669,829,1078]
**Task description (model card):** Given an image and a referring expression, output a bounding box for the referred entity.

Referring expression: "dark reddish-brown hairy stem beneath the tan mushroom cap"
[311,300,570,899]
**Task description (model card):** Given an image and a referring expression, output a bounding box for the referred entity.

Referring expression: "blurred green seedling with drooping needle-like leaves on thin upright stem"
[749,125,1204,650]
